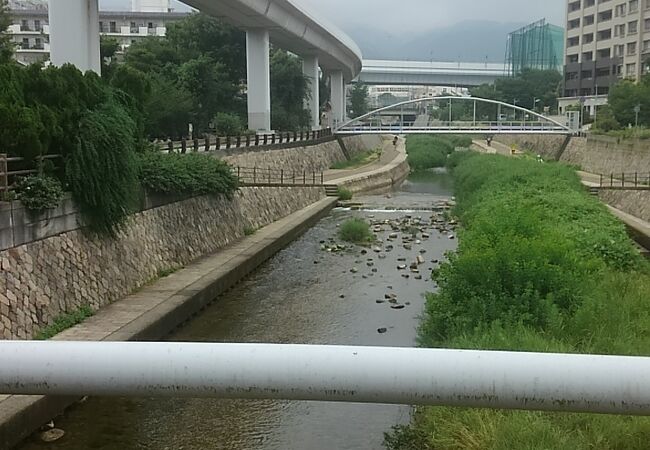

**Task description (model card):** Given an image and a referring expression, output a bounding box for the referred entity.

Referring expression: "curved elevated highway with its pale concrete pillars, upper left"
[49,0,362,132]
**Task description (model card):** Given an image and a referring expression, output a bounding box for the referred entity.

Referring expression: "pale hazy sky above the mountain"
[100,0,566,32]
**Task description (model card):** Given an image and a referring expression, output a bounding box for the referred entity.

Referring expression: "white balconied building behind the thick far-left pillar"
[7,0,189,64]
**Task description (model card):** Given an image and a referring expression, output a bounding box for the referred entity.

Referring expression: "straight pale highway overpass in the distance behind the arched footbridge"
[357,59,508,87]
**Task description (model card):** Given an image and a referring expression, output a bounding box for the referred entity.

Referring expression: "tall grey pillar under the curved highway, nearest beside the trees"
[246,29,271,133]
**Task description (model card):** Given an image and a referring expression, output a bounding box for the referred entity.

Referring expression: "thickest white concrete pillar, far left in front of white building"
[49,0,102,73]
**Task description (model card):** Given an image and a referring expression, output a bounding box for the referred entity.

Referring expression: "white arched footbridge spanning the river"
[335,96,578,135]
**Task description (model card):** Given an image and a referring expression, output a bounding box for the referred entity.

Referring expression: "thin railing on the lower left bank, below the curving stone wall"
[232,167,325,187]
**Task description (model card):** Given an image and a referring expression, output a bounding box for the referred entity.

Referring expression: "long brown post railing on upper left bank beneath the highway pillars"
[154,128,332,153]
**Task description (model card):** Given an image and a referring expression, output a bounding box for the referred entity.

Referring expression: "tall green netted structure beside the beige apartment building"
[506,19,564,76]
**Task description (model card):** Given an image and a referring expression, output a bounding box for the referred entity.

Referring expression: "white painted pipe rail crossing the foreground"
[0,341,650,415]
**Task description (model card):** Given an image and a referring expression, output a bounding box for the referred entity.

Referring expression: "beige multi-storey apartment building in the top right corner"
[559,0,650,114]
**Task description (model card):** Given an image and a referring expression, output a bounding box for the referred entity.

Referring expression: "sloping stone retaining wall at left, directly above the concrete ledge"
[0,188,324,339]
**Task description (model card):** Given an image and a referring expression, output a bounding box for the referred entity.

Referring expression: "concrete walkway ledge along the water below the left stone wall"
[0,134,404,448]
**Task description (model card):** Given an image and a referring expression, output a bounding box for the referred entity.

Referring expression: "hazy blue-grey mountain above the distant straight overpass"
[346,21,524,62]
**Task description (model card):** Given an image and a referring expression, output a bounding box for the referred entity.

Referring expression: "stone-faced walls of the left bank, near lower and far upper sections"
[0,136,382,339]
